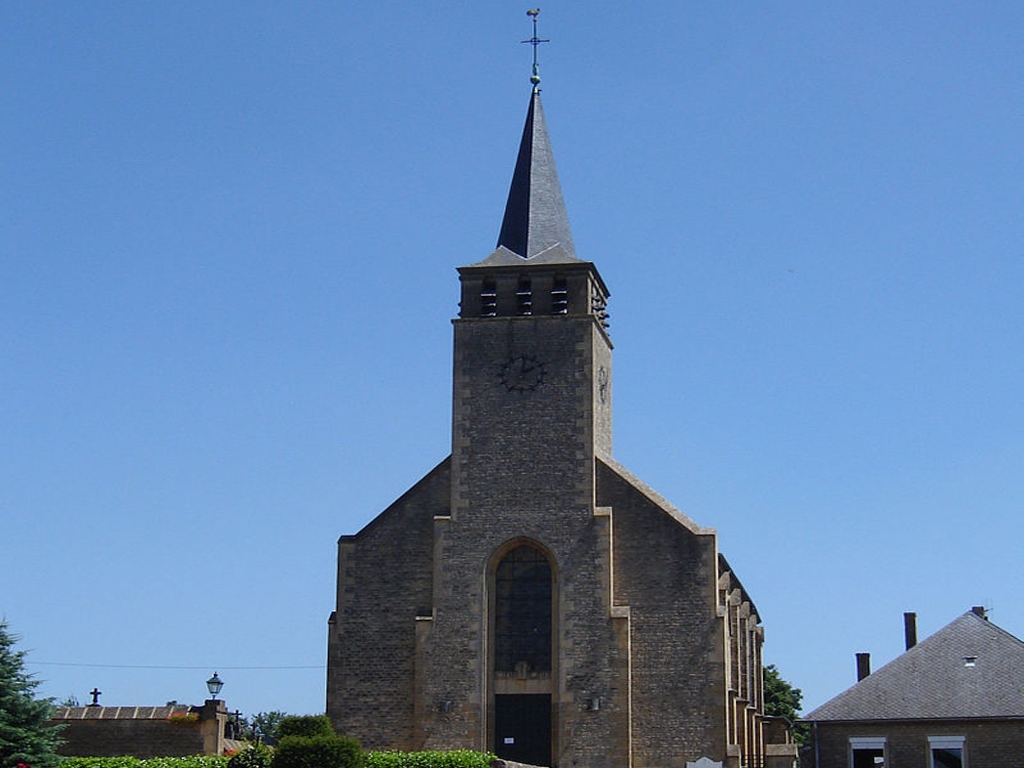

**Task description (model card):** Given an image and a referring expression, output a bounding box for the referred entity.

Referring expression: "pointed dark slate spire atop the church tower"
[498,87,577,260]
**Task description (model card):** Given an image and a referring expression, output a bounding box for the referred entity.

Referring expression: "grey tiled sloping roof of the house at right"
[802,611,1024,721]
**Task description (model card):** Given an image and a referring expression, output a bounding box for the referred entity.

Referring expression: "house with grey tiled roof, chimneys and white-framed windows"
[803,607,1024,768]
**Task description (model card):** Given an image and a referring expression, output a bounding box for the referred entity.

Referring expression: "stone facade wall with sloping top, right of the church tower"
[598,463,727,768]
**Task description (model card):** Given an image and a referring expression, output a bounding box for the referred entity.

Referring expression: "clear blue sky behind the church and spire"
[0,0,1024,713]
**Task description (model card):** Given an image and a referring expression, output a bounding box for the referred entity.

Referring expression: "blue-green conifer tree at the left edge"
[0,620,60,768]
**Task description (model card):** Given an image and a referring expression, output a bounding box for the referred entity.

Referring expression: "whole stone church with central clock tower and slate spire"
[327,64,796,768]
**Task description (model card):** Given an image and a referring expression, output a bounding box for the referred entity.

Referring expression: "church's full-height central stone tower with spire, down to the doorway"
[407,81,628,765]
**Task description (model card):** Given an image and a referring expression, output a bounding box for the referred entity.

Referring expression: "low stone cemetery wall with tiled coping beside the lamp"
[49,699,239,758]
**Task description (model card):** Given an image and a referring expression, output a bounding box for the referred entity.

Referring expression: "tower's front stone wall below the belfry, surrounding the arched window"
[413,315,629,768]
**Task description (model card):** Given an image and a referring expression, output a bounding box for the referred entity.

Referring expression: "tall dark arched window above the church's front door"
[495,545,551,672]
